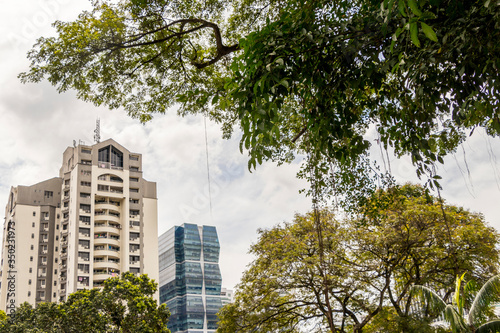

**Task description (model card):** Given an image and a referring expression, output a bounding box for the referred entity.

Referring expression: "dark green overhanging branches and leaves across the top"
[20,0,500,200]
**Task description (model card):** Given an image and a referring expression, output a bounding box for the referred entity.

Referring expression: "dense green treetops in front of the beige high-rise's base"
[0,272,170,333]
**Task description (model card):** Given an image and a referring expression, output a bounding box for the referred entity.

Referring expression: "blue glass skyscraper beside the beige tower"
[158,223,225,333]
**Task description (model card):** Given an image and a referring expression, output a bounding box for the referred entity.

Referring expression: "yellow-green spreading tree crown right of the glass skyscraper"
[218,185,499,333]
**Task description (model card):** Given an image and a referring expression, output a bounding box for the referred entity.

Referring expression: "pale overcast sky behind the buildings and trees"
[0,0,500,288]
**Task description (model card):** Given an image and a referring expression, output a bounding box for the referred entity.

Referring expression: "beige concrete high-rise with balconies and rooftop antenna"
[0,139,158,313]
